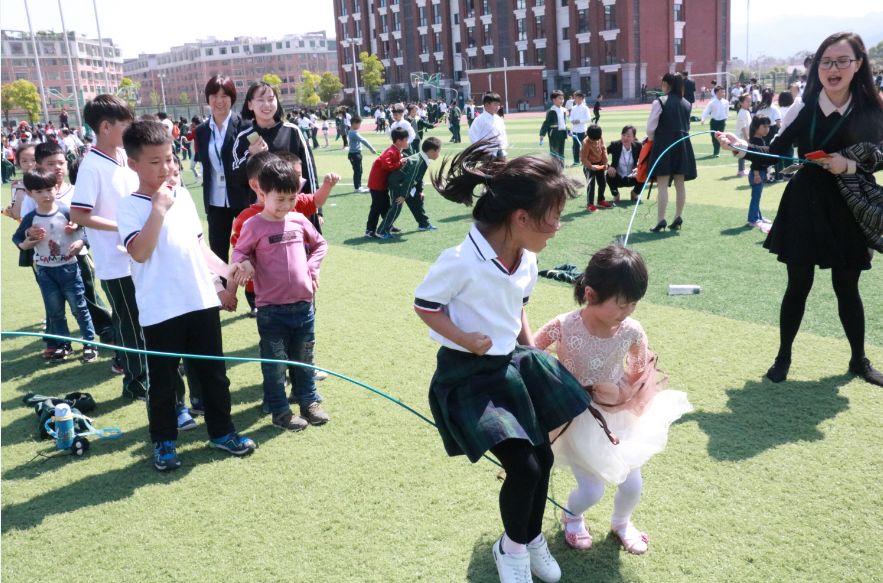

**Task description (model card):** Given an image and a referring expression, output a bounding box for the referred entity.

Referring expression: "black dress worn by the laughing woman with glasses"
[752,99,881,269]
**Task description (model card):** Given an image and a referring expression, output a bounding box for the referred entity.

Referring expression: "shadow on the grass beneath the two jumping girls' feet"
[466,527,635,583]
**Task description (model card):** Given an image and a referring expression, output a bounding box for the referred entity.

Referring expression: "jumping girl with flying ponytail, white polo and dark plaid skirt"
[414,141,590,583]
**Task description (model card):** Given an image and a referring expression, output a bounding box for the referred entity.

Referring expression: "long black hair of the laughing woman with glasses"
[803,32,883,139]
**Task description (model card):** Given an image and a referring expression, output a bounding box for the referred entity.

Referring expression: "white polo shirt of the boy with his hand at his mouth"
[117,187,221,326]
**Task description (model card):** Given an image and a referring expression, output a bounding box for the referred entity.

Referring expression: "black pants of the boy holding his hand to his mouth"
[144,308,233,441]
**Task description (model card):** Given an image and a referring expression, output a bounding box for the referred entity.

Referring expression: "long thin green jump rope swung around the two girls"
[0,130,814,515]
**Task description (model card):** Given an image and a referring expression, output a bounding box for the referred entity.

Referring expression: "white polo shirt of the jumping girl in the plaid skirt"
[414,225,537,355]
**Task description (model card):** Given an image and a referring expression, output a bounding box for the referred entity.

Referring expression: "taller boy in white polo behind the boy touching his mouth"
[70,95,147,400]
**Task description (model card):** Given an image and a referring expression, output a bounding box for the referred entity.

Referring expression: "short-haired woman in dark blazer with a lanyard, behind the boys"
[196,75,253,261]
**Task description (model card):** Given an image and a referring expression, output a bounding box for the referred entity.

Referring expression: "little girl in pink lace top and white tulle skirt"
[536,245,693,555]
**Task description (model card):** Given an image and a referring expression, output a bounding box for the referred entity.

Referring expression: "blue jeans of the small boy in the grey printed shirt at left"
[37,263,95,348]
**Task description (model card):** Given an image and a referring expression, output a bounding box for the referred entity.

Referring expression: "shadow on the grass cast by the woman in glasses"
[680,374,852,461]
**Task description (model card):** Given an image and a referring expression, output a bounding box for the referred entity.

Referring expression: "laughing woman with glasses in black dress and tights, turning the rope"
[719,32,883,386]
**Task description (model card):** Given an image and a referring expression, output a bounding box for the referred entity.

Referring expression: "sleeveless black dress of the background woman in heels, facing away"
[648,93,696,180]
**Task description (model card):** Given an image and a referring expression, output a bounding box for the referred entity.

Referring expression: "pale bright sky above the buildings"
[0,0,883,59]
